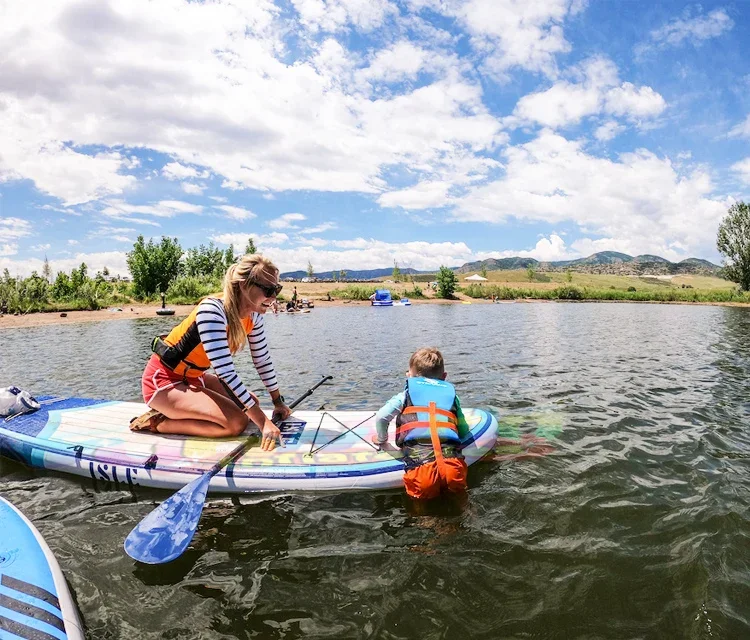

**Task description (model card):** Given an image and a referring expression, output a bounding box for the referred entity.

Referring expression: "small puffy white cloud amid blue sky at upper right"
[509,57,666,127]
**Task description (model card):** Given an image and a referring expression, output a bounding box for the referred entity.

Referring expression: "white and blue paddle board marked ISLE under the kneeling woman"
[0,398,497,493]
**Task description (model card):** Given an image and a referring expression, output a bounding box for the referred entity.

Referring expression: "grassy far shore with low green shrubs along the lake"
[0,265,750,326]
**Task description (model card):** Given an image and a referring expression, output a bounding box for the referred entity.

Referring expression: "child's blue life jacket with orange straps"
[396,378,461,450]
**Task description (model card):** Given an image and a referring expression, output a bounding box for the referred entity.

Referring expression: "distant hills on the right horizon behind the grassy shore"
[456,251,721,276]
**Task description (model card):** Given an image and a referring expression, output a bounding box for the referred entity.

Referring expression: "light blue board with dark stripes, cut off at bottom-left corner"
[0,498,84,640]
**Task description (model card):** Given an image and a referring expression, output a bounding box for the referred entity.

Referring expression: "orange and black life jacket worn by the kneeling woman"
[151,296,253,378]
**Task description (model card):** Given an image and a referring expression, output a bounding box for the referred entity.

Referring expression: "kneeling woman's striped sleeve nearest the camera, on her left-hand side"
[196,298,258,409]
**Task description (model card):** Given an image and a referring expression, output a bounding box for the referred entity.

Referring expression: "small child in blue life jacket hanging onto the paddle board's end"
[372,347,469,499]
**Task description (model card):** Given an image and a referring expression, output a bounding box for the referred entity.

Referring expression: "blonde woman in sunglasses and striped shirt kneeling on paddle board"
[130,254,291,451]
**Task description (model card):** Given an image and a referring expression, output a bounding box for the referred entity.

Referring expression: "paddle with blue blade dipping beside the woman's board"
[125,376,333,564]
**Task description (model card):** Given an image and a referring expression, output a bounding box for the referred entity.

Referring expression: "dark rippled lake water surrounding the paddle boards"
[0,303,750,640]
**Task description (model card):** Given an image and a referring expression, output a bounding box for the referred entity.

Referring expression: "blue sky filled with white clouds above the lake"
[0,0,750,276]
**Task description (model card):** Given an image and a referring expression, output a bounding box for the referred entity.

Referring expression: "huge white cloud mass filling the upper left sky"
[0,0,506,204]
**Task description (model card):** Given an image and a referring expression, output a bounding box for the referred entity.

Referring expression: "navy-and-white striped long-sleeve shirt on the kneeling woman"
[196,298,279,408]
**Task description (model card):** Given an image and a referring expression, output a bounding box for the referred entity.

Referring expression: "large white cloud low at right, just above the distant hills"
[455,131,727,259]
